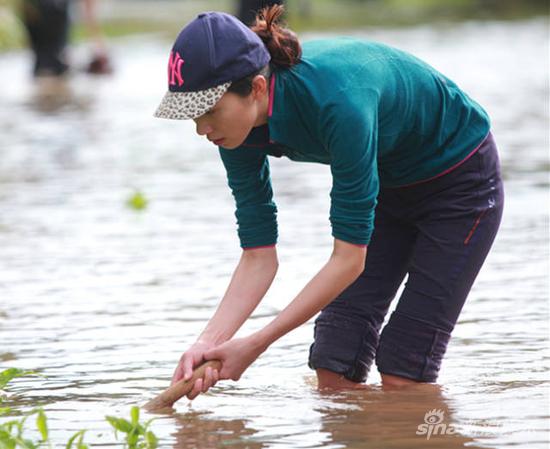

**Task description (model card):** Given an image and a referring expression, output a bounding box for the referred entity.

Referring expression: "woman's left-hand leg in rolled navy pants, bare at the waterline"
[309,205,415,388]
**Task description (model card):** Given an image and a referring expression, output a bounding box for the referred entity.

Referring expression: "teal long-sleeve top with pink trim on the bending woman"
[219,38,490,249]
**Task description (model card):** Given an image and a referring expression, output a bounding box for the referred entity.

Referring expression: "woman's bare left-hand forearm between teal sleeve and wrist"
[198,246,278,345]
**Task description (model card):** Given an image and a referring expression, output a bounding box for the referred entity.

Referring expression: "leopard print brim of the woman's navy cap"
[154,83,231,120]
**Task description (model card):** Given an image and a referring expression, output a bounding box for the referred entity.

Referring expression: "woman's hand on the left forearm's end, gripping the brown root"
[170,340,219,399]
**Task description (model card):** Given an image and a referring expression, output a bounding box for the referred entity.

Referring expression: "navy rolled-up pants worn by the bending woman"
[309,134,504,382]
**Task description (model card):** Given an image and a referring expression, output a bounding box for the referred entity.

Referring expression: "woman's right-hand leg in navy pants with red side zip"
[376,132,504,384]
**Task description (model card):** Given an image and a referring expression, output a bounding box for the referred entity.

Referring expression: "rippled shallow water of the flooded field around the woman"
[0,15,550,449]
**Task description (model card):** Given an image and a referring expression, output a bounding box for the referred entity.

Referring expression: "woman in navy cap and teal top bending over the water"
[156,6,503,399]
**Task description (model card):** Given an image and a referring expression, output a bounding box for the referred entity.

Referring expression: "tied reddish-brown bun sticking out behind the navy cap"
[250,5,302,68]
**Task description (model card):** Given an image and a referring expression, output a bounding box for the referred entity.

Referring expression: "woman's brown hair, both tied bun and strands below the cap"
[227,5,302,97]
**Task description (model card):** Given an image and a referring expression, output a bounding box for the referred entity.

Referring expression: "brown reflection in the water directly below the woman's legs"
[318,384,494,449]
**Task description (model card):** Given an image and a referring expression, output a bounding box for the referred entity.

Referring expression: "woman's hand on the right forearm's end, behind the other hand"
[203,334,267,380]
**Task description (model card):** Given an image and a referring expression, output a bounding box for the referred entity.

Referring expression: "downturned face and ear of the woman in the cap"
[194,75,268,149]
